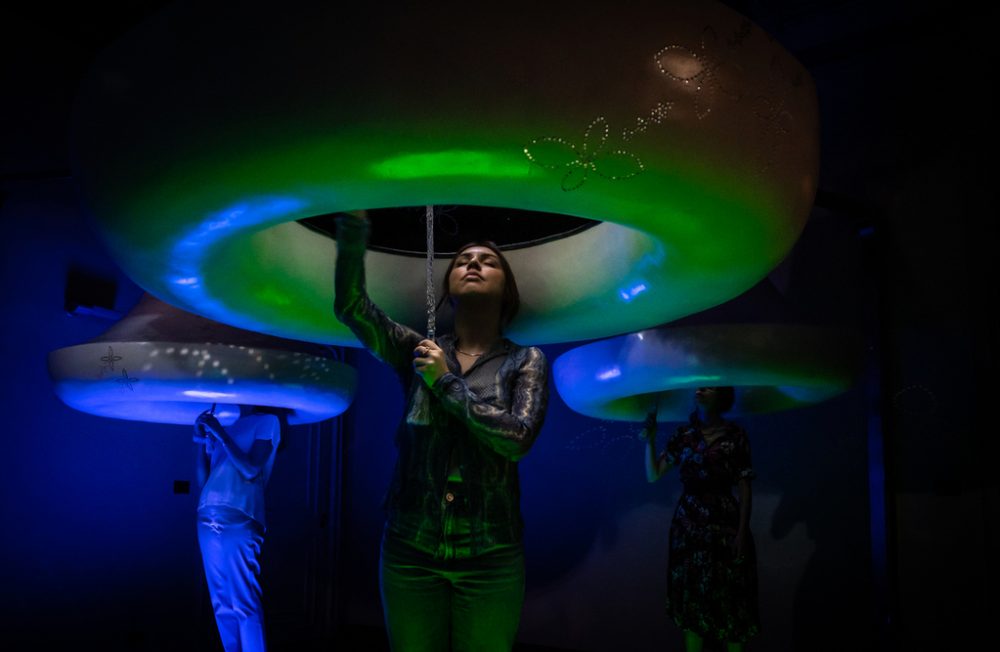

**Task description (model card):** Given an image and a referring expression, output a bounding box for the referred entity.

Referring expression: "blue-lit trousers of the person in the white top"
[198,507,266,652]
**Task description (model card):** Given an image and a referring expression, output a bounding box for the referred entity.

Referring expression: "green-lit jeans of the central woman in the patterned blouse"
[380,484,524,652]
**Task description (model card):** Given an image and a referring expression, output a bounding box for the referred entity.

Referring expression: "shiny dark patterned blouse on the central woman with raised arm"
[334,220,549,554]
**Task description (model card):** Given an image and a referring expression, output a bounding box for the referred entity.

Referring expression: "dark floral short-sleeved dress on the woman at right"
[663,422,760,642]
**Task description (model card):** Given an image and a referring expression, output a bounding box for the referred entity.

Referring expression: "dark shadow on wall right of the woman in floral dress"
[769,390,872,652]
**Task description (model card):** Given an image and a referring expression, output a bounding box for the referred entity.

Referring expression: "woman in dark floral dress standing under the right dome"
[643,387,760,652]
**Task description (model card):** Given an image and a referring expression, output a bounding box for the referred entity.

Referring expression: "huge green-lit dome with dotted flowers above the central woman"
[75,0,818,345]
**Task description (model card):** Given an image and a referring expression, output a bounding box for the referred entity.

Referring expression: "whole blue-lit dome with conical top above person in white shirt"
[49,294,357,425]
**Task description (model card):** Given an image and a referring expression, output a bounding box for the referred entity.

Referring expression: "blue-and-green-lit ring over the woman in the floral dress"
[553,324,861,421]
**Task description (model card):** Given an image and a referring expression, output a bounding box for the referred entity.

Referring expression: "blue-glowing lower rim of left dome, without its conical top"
[49,341,357,425]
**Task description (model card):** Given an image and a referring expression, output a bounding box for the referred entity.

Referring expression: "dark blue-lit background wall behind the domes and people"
[0,2,1000,650]
